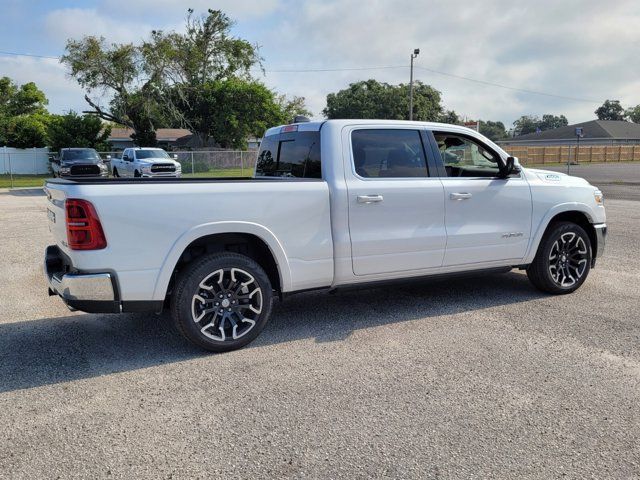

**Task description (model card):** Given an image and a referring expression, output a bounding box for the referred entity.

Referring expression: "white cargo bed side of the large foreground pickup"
[46,177,333,303]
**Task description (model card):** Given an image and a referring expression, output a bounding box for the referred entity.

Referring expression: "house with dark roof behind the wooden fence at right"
[500,120,640,147]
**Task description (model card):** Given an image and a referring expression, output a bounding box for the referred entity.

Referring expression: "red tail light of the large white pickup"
[64,198,107,250]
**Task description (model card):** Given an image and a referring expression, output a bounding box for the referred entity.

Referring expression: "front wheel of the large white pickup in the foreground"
[527,222,593,295]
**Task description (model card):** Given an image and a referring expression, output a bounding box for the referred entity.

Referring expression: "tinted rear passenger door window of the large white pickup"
[351,128,429,178]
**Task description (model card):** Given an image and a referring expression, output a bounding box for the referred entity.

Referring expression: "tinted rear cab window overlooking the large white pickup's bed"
[256,132,322,178]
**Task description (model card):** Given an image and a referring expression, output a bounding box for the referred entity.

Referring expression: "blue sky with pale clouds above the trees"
[0,0,640,125]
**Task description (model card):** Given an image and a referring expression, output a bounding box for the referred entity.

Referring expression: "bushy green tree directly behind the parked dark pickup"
[48,111,111,151]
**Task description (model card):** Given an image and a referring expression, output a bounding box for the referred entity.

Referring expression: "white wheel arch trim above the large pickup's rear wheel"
[153,222,291,300]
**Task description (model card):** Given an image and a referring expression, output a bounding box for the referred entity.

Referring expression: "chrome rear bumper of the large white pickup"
[44,245,121,313]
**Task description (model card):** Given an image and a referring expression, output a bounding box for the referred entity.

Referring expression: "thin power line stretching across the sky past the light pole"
[0,50,600,104]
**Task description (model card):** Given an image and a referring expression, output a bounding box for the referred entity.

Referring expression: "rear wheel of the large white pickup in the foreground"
[171,252,273,352]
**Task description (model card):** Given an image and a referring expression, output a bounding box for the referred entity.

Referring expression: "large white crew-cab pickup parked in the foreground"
[45,120,607,352]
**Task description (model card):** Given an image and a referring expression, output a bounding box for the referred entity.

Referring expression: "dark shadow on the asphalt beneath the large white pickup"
[0,273,543,393]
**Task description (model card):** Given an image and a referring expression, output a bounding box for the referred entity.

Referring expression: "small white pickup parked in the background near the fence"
[111,147,182,178]
